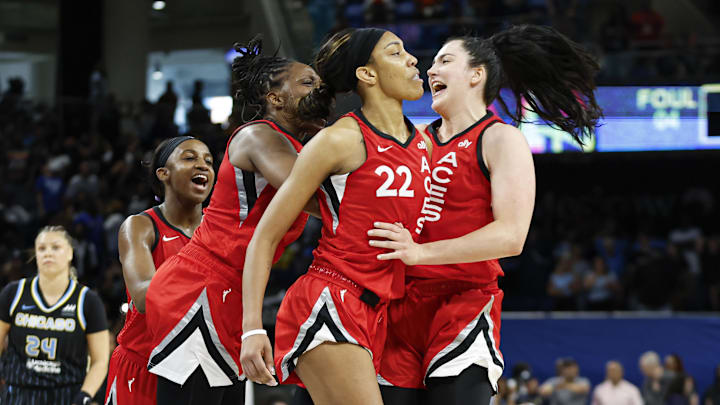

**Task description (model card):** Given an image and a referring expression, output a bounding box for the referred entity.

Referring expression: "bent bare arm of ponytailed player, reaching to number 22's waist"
[368,124,535,265]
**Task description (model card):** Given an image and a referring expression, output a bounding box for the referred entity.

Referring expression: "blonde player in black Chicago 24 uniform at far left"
[0,226,110,405]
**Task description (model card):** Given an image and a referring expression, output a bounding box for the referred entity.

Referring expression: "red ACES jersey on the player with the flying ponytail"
[407,111,503,284]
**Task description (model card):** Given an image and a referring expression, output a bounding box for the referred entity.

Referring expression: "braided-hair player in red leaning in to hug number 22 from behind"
[145,38,329,405]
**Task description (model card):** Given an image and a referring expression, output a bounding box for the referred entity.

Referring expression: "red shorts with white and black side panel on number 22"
[275,265,387,384]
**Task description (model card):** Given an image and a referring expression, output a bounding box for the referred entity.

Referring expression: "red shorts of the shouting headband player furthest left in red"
[105,346,157,405]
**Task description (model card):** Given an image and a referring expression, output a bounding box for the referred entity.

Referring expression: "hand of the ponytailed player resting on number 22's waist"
[368,222,421,266]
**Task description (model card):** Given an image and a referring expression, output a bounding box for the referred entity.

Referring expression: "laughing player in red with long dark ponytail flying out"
[368,26,601,405]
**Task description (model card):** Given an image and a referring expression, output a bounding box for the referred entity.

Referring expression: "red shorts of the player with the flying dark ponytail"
[378,279,504,391]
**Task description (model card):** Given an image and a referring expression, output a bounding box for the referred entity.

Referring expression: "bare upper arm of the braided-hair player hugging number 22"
[228,124,320,218]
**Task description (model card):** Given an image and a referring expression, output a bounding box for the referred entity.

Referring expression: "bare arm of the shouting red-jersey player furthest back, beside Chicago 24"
[118,215,156,313]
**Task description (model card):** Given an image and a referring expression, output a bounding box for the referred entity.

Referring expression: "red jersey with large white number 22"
[313,110,430,299]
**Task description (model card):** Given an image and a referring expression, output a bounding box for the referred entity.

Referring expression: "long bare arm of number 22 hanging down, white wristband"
[240,120,365,384]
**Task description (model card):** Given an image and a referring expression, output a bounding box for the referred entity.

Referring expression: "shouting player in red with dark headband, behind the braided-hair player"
[105,136,215,405]
